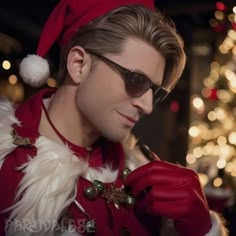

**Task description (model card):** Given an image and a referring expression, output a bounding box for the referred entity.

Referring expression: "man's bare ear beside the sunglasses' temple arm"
[67,46,91,84]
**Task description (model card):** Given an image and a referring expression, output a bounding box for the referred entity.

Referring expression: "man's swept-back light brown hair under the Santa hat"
[57,5,186,90]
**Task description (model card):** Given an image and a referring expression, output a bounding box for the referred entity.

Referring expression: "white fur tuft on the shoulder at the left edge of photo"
[0,97,20,169]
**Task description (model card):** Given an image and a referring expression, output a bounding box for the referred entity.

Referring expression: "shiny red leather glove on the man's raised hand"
[125,161,211,236]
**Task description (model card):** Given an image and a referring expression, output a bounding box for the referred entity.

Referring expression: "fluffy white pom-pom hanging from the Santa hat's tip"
[20,55,50,87]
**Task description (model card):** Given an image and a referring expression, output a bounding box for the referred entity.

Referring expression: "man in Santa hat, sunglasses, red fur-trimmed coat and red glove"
[0,0,227,236]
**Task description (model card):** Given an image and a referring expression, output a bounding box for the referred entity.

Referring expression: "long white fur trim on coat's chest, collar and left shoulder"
[0,99,118,235]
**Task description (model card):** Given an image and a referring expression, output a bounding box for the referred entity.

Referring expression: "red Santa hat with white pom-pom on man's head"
[20,0,154,87]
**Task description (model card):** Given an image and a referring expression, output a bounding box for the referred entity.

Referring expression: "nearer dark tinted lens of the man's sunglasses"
[125,72,150,97]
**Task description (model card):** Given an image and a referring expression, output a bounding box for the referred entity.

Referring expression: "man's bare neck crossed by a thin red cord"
[40,85,99,147]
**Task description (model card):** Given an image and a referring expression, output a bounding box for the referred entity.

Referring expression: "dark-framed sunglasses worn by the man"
[86,49,168,106]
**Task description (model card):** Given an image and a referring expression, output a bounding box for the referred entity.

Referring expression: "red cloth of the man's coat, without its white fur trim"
[0,90,159,236]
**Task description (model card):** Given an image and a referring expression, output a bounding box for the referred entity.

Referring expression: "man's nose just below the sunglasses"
[131,89,153,114]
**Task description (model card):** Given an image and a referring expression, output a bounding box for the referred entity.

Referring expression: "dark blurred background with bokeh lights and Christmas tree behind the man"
[0,0,236,235]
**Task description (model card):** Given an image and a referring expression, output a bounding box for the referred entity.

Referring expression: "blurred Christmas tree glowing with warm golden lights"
[186,2,236,212]
